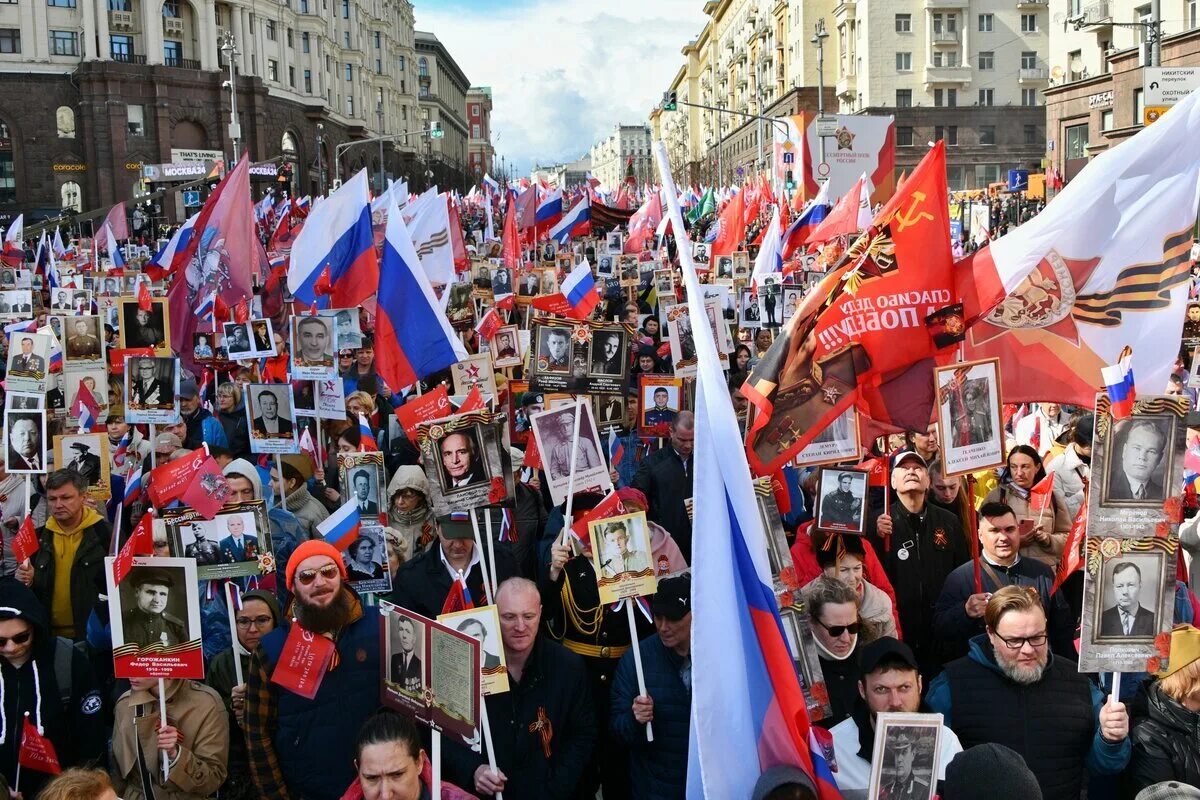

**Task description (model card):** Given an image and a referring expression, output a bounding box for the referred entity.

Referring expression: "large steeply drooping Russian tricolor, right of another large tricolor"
[374,199,467,391]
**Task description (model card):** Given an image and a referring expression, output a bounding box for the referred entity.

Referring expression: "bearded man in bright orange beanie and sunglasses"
[245,540,379,800]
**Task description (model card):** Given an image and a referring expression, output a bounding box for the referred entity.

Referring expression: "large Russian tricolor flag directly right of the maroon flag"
[288,169,376,308]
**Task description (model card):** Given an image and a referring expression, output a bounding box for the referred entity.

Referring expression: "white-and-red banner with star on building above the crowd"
[773,114,896,203]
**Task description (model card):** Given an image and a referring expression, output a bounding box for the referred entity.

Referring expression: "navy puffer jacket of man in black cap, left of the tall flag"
[608,633,691,800]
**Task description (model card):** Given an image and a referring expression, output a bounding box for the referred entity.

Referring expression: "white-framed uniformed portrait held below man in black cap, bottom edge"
[866,712,942,800]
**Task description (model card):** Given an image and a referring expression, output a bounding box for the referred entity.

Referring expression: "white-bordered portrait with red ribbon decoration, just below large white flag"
[934,359,1004,477]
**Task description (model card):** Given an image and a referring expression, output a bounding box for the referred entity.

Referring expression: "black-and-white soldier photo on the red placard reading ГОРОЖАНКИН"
[120,566,191,649]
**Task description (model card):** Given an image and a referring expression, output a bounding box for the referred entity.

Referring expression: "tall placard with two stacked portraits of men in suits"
[1076,395,1190,673]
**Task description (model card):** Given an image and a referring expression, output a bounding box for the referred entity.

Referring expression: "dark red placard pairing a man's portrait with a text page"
[379,601,481,752]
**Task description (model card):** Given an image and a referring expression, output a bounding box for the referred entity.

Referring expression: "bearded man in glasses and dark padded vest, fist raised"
[925,587,1132,798]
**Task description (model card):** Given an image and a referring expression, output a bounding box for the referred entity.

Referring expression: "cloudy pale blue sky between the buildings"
[414,0,706,175]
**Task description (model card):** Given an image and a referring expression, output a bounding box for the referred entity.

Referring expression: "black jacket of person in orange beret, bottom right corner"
[1126,681,1200,796]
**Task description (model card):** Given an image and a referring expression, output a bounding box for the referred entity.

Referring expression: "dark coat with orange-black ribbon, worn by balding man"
[443,634,598,800]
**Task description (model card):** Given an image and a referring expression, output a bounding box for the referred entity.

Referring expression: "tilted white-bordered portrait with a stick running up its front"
[529,401,612,505]
